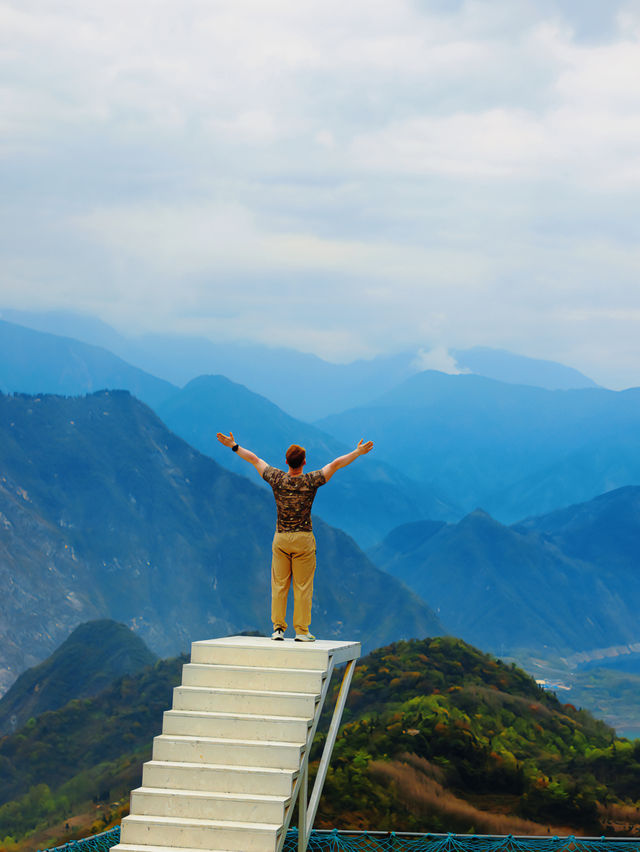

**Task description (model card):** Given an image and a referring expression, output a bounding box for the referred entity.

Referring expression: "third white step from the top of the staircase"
[173,686,320,719]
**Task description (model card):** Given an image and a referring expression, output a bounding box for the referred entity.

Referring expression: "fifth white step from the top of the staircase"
[153,734,304,772]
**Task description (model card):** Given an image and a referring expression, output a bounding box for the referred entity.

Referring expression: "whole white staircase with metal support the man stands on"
[114,636,360,852]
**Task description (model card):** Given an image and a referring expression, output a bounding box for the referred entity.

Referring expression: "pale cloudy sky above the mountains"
[0,0,640,388]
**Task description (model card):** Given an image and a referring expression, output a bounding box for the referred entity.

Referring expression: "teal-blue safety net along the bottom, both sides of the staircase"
[37,826,640,852]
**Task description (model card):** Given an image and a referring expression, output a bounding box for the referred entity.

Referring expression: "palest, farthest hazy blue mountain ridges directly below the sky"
[0,310,595,421]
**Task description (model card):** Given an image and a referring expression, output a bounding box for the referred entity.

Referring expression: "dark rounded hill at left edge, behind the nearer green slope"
[0,619,157,735]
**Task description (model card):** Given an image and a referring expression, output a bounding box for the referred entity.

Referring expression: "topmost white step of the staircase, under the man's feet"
[191,639,330,671]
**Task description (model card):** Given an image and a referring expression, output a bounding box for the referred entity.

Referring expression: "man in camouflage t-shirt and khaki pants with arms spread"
[216,432,373,642]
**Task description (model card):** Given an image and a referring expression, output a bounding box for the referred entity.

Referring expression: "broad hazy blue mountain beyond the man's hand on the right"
[316,371,640,523]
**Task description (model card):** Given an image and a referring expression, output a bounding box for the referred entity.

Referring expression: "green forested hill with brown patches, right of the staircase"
[312,638,640,834]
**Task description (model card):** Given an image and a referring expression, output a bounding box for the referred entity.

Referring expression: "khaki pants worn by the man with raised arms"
[271,532,316,633]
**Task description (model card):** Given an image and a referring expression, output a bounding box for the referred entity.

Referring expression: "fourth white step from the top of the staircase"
[162,710,311,744]
